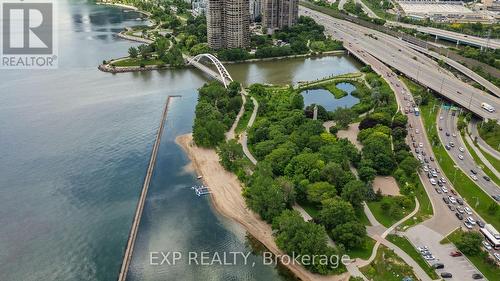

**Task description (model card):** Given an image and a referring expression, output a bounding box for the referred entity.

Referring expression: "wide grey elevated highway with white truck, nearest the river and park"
[300,7,500,120]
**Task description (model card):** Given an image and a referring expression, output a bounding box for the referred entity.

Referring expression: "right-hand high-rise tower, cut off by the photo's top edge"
[261,0,299,34]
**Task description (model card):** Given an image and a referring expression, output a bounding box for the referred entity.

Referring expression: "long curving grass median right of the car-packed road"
[403,79,500,229]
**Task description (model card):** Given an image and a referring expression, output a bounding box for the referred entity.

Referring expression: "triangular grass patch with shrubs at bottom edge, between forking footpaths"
[360,245,418,281]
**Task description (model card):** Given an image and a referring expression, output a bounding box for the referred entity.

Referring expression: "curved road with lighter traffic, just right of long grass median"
[437,110,500,196]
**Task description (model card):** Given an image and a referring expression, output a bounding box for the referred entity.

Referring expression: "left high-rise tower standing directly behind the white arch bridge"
[206,0,250,49]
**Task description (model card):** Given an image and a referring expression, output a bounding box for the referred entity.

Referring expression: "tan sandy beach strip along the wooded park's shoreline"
[175,134,349,281]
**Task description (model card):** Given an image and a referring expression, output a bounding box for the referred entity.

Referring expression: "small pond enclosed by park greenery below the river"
[302,83,359,111]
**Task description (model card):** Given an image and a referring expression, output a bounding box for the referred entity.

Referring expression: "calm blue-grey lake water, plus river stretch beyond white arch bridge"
[0,1,358,281]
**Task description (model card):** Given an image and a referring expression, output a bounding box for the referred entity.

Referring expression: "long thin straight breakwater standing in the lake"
[118,95,180,281]
